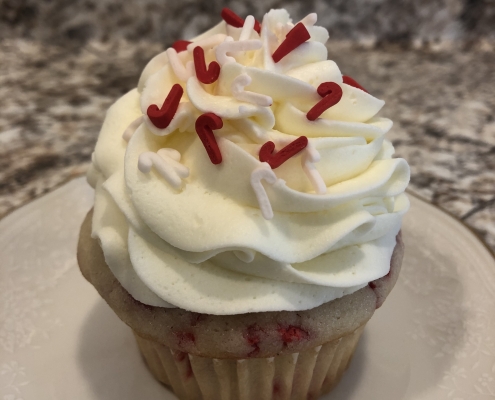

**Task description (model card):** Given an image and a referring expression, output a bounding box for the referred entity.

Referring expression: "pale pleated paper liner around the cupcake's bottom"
[134,325,364,400]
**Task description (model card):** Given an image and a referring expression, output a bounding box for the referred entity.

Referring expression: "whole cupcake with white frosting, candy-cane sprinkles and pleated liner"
[78,9,409,400]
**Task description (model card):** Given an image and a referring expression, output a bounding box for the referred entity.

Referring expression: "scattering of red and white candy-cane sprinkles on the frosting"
[130,8,366,219]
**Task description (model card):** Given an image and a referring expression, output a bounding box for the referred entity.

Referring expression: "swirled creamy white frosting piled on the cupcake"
[88,10,409,315]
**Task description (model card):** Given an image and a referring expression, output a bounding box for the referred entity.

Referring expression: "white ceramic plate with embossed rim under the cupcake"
[0,178,495,400]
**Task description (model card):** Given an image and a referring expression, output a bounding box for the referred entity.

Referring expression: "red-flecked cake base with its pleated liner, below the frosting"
[78,211,404,400]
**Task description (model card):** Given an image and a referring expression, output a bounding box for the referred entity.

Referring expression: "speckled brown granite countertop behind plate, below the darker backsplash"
[0,39,495,250]
